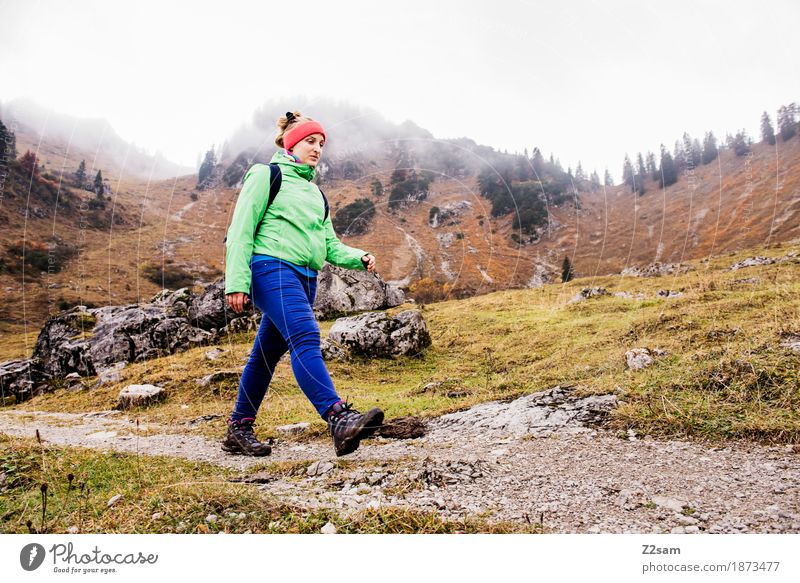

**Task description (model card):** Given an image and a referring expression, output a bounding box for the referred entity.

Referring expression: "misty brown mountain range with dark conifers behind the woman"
[0,102,800,333]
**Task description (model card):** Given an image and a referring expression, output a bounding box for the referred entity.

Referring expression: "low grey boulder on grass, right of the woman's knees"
[328,310,431,358]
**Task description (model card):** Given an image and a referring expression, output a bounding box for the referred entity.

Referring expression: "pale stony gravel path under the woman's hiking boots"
[0,386,800,533]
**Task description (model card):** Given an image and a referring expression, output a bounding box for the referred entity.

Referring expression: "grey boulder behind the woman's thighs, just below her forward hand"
[314,263,405,319]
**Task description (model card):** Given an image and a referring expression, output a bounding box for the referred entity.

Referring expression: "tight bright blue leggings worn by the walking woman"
[231,259,340,420]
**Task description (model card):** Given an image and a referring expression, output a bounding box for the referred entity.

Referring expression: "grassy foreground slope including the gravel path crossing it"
[0,244,800,533]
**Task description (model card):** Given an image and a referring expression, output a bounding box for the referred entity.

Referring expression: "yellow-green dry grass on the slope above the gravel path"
[6,242,800,442]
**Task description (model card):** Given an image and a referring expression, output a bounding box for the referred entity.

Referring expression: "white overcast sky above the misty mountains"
[0,0,800,178]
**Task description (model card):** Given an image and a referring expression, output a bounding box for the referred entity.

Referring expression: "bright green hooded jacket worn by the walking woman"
[225,150,369,294]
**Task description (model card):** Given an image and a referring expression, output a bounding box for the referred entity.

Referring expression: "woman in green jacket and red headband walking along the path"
[222,112,383,456]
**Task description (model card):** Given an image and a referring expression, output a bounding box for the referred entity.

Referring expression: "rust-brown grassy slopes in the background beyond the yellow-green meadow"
[0,105,800,344]
